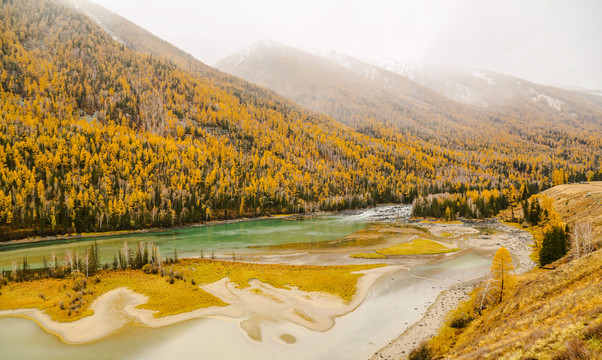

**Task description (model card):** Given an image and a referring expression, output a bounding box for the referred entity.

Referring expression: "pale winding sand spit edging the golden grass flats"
[0,266,406,344]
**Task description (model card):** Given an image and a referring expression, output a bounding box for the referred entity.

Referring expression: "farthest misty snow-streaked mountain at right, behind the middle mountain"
[379,62,602,126]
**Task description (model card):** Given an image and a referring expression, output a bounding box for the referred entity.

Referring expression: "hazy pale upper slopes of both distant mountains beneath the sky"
[216,41,602,132]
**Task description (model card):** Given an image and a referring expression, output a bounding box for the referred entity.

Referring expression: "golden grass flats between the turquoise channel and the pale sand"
[0,259,383,321]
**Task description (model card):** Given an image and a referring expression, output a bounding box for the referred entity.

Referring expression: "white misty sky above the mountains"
[93,0,602,89]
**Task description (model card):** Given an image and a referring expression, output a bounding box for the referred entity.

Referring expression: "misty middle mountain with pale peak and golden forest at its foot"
[217,42,602,178]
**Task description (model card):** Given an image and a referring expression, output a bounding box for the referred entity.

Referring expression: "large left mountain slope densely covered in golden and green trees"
[0,0,600,239]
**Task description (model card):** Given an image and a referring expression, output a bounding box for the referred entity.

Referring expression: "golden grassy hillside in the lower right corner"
[422,251,602,360]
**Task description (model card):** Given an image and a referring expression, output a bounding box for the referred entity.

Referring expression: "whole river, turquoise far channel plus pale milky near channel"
[0,204,491,360]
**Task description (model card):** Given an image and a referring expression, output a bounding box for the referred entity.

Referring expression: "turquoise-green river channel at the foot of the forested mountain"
[0,216,369,270]
